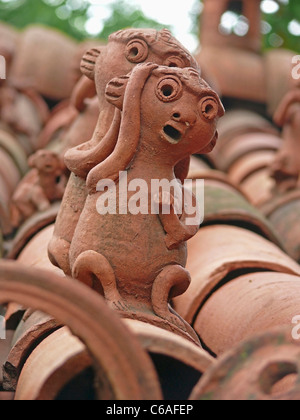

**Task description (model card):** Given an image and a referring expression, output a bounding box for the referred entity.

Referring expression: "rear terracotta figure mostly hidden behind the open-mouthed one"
[49,29,198,275]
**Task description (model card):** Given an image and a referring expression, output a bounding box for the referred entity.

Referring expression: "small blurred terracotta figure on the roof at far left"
[11,150,66,228]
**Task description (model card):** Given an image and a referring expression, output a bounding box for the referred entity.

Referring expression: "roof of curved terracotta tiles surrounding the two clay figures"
[0,16,300,400]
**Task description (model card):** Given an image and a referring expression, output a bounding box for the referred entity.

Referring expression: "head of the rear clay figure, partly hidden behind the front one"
[81,29,198,99]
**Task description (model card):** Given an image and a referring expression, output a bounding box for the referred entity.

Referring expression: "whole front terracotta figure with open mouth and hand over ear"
[70,63,224,342]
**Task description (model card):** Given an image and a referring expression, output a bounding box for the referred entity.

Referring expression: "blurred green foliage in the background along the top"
[0,0,300,51]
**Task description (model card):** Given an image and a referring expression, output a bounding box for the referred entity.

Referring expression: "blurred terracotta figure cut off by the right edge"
[271,86,300,193]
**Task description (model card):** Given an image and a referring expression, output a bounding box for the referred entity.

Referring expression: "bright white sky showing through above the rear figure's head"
[86,0,201,51]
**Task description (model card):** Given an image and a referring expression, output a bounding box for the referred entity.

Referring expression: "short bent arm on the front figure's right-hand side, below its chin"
[156,190,199,249]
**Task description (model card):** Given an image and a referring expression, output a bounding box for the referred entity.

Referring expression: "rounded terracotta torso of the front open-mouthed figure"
[70,164,187,301]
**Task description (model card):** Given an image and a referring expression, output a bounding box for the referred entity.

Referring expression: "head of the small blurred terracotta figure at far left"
[28,150,65,176]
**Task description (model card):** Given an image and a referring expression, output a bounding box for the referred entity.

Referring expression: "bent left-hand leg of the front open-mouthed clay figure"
[72,250,127,311]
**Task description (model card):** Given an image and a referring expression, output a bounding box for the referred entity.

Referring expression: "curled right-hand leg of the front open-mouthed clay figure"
[152,265,191,332]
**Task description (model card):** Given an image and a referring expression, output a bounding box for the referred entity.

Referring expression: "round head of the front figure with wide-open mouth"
[106,64,225,160]
